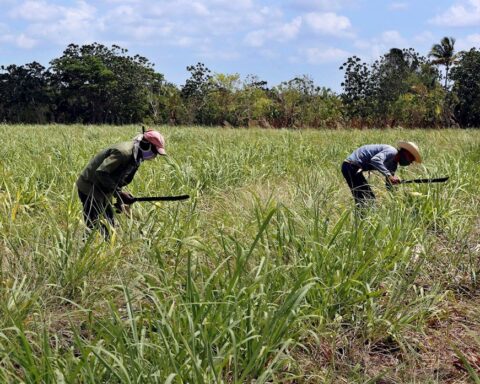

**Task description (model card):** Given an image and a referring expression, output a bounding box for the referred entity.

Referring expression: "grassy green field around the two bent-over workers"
[0,125,480,383]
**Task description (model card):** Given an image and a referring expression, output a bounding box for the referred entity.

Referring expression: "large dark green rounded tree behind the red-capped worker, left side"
[50,43,163,124]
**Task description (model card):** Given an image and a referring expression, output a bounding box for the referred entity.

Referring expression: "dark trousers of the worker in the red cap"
[78,191,115,240]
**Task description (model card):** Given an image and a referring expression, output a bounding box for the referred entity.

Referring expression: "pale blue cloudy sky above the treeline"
[0,0,480,92]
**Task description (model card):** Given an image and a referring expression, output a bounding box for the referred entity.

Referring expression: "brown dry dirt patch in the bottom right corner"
[295,293,480,384]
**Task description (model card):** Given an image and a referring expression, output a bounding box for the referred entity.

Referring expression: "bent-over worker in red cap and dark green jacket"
[77,130,166,239]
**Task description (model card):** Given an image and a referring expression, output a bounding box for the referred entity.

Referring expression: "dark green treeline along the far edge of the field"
[0,38,480,128]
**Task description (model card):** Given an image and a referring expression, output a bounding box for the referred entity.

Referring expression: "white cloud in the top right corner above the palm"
[430,0,480,27]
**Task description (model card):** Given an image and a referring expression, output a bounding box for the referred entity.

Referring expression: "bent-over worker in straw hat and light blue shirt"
[342,141,422,207]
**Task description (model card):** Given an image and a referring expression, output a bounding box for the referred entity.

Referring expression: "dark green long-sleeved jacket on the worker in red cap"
[77,141,141,199]
